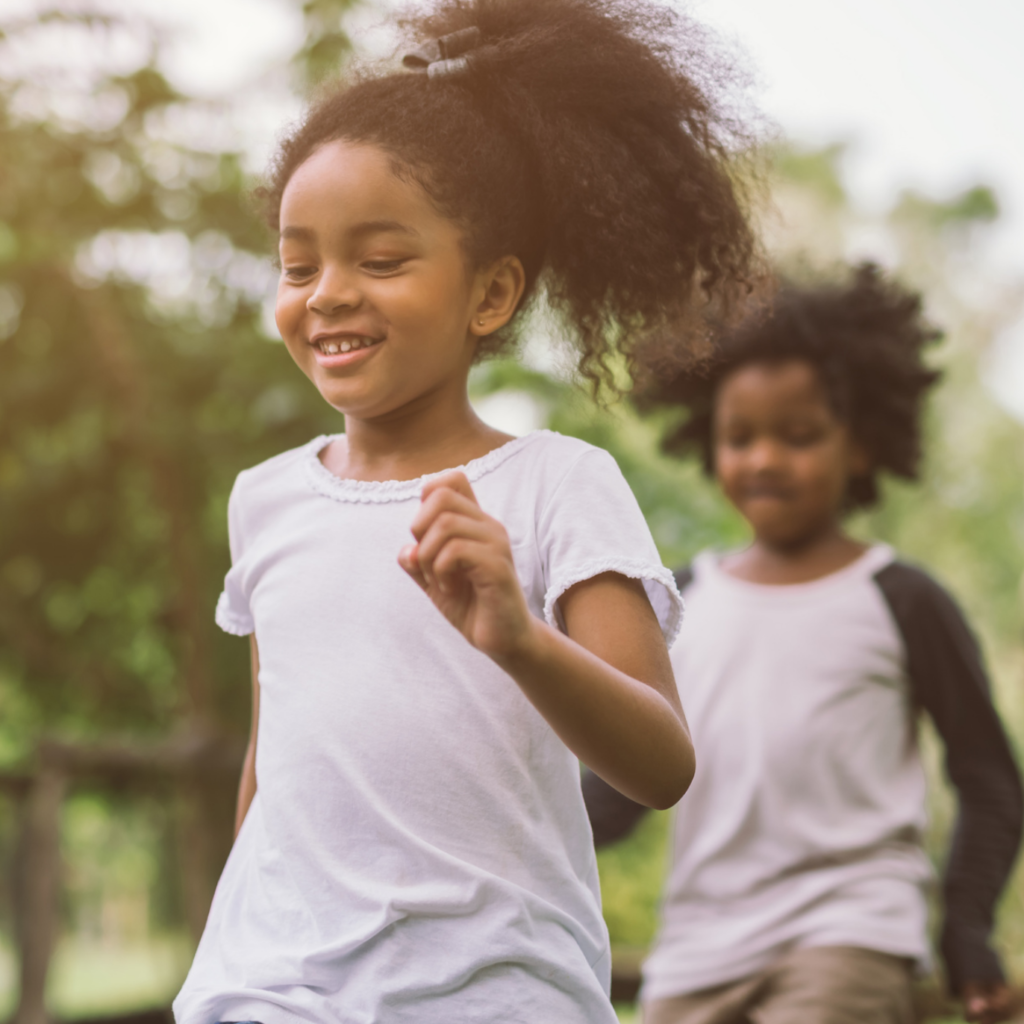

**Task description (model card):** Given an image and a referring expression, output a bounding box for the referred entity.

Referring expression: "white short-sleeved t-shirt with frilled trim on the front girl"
[174,431,681,1024]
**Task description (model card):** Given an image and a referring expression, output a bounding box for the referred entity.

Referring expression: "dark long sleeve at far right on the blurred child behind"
[876,562,1024,1003]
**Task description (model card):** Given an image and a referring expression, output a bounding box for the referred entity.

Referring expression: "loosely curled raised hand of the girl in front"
[398,472,536,658]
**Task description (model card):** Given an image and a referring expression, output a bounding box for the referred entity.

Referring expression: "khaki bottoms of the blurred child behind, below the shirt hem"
[642,946,914,1024]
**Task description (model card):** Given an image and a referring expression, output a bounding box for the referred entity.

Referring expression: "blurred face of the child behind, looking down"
[714,359,867,548]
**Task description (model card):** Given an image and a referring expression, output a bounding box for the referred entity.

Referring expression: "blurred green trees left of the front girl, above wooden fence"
[0,3,354,761]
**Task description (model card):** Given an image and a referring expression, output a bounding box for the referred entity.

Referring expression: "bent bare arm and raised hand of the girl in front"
[399,472,694,808]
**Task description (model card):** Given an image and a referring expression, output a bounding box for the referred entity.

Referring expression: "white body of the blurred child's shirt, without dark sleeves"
[642,546,932,999]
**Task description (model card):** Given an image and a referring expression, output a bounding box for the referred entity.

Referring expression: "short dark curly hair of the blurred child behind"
[641,263,942,510]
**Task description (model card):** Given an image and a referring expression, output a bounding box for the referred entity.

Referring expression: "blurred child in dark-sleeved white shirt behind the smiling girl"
[585,266,1021,1024]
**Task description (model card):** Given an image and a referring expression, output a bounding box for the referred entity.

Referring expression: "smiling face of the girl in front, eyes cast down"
[276,141,494,419]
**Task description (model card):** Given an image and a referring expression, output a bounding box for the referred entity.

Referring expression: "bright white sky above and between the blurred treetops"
[12,0,1024,418]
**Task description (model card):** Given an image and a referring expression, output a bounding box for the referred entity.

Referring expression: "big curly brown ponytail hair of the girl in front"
[258,0,758,389]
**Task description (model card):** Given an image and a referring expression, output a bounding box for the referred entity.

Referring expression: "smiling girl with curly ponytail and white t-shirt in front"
[175,0,753,1024]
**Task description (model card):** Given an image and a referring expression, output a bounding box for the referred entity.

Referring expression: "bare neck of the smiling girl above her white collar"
[321,397,512,480]
